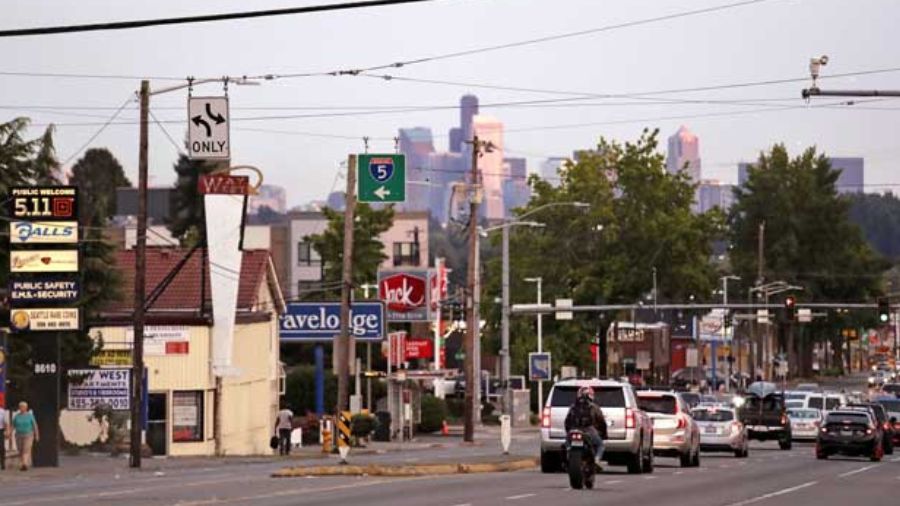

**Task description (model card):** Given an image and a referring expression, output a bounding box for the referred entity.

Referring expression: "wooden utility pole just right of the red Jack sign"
[463,135,493,443]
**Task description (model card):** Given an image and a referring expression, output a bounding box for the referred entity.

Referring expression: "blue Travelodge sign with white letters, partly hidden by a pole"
[278,302,385,343]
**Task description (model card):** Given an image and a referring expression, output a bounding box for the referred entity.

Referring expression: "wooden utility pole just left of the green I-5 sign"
[334,155,356,412]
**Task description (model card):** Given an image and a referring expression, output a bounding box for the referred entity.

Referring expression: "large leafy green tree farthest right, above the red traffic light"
[729,144,887,374]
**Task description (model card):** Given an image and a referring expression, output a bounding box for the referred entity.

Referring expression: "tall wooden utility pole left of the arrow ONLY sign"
[130,80,150,468]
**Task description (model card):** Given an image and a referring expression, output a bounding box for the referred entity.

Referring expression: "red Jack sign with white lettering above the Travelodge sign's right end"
[378,269,431,322]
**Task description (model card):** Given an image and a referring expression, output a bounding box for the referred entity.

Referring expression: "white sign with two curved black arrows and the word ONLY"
[188,97,231,160]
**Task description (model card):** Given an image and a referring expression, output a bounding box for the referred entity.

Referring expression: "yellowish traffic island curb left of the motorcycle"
[272,459,538,478]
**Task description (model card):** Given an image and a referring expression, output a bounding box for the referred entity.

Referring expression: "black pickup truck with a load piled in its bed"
[740,381,791,450]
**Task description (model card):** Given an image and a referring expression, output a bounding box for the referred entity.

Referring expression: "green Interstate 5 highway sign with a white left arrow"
[356,153,406,203]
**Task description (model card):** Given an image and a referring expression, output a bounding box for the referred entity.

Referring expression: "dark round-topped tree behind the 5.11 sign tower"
[69,148,131,224]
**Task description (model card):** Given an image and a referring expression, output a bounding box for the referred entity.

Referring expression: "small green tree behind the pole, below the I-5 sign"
[307,203,394,293]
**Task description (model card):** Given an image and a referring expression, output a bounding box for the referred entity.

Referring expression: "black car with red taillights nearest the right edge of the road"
[816,410,884,462]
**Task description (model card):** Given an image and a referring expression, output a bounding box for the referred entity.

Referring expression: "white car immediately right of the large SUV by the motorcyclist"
[637,391,700,467]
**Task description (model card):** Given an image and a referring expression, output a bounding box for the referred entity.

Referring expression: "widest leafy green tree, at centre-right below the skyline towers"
[485,130,724,378]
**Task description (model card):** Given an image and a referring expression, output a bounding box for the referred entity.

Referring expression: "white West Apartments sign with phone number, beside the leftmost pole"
[69,369,131,411]
